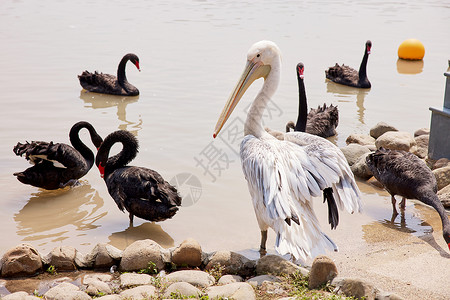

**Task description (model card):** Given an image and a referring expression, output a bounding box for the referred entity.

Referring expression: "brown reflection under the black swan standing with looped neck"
[109,222,175,249]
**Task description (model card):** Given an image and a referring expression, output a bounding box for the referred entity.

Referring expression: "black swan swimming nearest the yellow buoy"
[325,41,372,88]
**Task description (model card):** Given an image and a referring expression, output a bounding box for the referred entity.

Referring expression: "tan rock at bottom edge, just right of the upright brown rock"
[332,278,378,300]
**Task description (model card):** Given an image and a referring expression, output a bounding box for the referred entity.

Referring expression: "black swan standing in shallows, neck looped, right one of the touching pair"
[95,130,181,225]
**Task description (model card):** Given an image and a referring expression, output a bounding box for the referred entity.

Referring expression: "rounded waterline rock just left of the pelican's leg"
[206,250,255,276]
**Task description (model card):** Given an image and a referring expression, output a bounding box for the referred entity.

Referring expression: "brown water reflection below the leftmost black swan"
[14,181,107,244]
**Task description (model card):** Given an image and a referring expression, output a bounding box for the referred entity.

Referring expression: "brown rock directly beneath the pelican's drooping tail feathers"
[256,255,309,276]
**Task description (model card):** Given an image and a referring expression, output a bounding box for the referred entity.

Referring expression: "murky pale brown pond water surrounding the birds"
[0,0,450,253]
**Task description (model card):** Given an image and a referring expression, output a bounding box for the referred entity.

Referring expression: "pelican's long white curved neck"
[244,57,281,138]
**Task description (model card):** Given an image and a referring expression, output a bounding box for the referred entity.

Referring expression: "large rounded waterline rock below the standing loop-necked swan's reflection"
[120,239,164,271]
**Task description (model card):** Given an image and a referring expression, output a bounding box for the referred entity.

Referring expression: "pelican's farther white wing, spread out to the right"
[284,132,362,213]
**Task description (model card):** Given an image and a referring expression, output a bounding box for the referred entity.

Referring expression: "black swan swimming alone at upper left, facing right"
[78,53,141,96]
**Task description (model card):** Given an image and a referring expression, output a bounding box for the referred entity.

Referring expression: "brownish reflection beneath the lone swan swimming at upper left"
[80,90,142,135]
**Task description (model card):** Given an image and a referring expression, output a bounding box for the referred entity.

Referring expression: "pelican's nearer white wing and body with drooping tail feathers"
[241,135,337,259]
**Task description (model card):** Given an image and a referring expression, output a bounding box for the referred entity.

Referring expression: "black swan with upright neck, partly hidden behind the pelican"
[286,62,339,138]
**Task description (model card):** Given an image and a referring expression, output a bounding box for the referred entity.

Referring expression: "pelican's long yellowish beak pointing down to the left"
[213,60,270,138]
